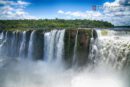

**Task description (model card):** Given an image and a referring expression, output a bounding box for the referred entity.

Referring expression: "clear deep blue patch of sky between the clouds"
[27,0,113,18]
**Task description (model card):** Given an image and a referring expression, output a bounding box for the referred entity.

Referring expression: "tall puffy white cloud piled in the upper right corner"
[103,0,130,25]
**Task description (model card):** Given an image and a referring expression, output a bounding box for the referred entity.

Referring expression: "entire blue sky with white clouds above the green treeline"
[0,0,130,25]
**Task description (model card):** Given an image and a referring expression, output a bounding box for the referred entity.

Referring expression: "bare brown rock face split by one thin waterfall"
[65,29,92,66]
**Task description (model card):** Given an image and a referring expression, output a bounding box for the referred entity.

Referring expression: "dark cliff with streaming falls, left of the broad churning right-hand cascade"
[0,29,93,66]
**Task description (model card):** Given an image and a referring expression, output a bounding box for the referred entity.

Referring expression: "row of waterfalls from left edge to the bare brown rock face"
[0,30,65,63]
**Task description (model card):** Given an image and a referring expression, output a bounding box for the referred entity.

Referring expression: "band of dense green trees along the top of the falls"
[0,19,114,29]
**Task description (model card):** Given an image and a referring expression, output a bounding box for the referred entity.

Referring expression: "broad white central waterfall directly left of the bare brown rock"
[44,30,65,62]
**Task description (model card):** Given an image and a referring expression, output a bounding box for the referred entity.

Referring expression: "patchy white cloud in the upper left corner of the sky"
[0,0,36,19]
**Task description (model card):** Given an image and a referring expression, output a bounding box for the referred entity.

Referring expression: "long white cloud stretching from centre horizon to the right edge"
[58,0,130,26]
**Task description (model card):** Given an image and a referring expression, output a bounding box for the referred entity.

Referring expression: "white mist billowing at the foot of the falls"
[0,60,124,87]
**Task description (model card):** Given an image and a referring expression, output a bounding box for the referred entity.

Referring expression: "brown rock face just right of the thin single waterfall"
[77,30,91,65]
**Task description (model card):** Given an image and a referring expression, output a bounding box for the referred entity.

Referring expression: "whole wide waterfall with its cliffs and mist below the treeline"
[0,29,130,87]
